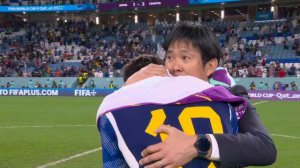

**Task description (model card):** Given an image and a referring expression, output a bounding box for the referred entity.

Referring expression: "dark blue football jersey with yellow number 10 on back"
[98,101,238,168]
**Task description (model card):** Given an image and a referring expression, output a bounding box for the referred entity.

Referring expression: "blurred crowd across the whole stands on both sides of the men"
[0,10,300,80]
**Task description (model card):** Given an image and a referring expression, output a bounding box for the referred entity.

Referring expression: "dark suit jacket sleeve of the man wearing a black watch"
[214,85,277,167]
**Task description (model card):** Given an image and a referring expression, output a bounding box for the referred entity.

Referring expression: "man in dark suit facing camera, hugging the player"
[126,24,276,167]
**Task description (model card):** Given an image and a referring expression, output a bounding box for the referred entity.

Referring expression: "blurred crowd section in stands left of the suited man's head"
[0,16,156,77]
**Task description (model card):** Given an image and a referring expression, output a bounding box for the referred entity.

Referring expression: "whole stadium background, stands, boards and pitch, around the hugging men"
[0,0,300,168]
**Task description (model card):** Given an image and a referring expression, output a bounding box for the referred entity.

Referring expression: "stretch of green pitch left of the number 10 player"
[0,97,102,168]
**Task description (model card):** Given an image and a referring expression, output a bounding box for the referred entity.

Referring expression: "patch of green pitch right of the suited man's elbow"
[253,101,300,168]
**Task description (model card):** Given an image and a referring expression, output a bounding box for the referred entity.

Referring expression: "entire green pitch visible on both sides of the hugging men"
[0,97,300,168]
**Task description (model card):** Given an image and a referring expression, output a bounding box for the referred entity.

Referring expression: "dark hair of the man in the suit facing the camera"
[163,22,221,65]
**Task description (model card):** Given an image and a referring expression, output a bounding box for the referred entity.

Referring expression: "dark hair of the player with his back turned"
[123,54,164,82]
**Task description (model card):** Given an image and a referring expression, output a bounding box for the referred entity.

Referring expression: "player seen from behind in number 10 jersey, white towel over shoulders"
[98,55,247,168]
